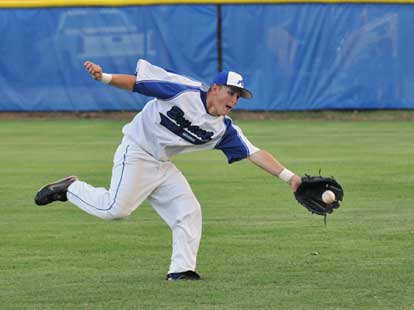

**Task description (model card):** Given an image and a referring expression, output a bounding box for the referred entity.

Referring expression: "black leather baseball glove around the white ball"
[294,175,344,219]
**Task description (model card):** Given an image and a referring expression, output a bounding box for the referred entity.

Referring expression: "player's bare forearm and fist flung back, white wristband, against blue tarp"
[83,60,135,91]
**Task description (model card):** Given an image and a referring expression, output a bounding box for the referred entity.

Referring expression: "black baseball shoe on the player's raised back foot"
[34,176,78,206]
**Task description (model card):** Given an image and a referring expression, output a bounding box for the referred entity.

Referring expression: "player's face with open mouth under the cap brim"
[209,85,240,116]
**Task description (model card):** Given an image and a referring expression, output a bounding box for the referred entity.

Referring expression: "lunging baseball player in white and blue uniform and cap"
[35,59,301,280]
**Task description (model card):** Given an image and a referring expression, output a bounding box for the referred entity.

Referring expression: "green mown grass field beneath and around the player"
[0,112,414,310]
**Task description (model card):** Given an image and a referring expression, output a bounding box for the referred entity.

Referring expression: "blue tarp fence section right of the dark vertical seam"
[223,4,414,110]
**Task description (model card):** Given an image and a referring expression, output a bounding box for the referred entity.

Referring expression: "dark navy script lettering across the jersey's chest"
[160,106,214,145]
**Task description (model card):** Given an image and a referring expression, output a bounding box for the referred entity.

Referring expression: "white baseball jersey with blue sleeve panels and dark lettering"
[123,59,259,163]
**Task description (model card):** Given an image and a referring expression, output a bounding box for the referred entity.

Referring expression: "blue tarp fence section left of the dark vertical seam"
[0,6,217,111]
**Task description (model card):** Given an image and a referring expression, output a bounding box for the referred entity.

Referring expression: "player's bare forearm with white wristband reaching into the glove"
[249,150,302,191]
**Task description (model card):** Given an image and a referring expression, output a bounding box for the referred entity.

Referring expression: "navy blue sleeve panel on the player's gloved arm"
[215,118,249,164]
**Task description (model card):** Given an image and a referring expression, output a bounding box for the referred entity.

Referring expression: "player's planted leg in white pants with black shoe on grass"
[149,163,202,280]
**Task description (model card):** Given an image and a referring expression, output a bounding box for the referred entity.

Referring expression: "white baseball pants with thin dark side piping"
[67,138,201,273]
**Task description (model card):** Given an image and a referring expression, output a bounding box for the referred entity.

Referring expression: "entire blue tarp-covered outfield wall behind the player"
[0,0,414,111]
